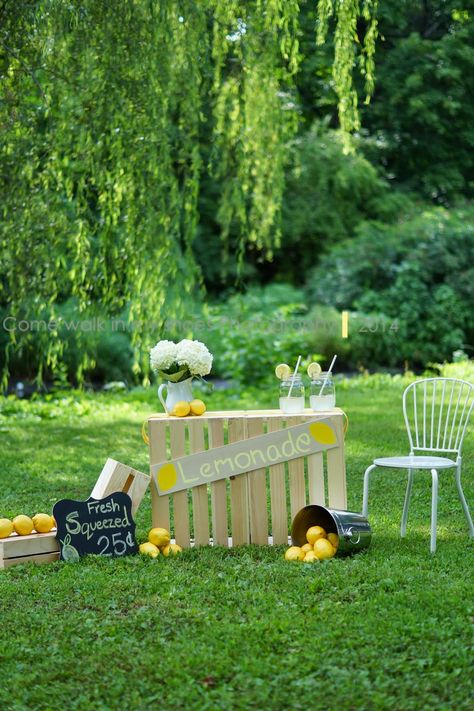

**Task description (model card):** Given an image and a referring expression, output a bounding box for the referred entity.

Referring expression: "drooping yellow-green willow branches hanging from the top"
[0,0,376,384]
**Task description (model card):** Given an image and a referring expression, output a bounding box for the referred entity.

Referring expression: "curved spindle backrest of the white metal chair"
[403,378,474,456]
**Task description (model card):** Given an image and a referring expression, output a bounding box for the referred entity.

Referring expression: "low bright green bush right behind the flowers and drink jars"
[186,284,356,384]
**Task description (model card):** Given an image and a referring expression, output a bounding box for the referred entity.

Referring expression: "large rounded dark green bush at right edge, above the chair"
[307,206,474,366]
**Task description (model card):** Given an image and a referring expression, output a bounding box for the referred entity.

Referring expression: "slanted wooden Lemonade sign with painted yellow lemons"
[151,419,338,494]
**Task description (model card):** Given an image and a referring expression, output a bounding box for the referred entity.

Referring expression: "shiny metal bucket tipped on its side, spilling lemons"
[291,504,372,556]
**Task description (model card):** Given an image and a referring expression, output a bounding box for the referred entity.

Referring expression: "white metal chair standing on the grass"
[362,378,474,553]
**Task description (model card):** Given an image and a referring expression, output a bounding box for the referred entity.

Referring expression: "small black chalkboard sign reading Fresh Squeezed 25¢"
[53,491,138,561]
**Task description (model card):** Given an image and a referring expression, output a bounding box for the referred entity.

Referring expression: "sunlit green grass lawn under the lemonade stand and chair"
[0,378,474,711]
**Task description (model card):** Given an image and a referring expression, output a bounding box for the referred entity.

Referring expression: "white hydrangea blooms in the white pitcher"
[150,338,212,383]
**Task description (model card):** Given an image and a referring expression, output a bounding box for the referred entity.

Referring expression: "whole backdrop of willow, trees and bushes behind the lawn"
[0,0,474,390]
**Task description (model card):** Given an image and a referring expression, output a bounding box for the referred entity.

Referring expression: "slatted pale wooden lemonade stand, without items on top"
[148,407,347,547]
